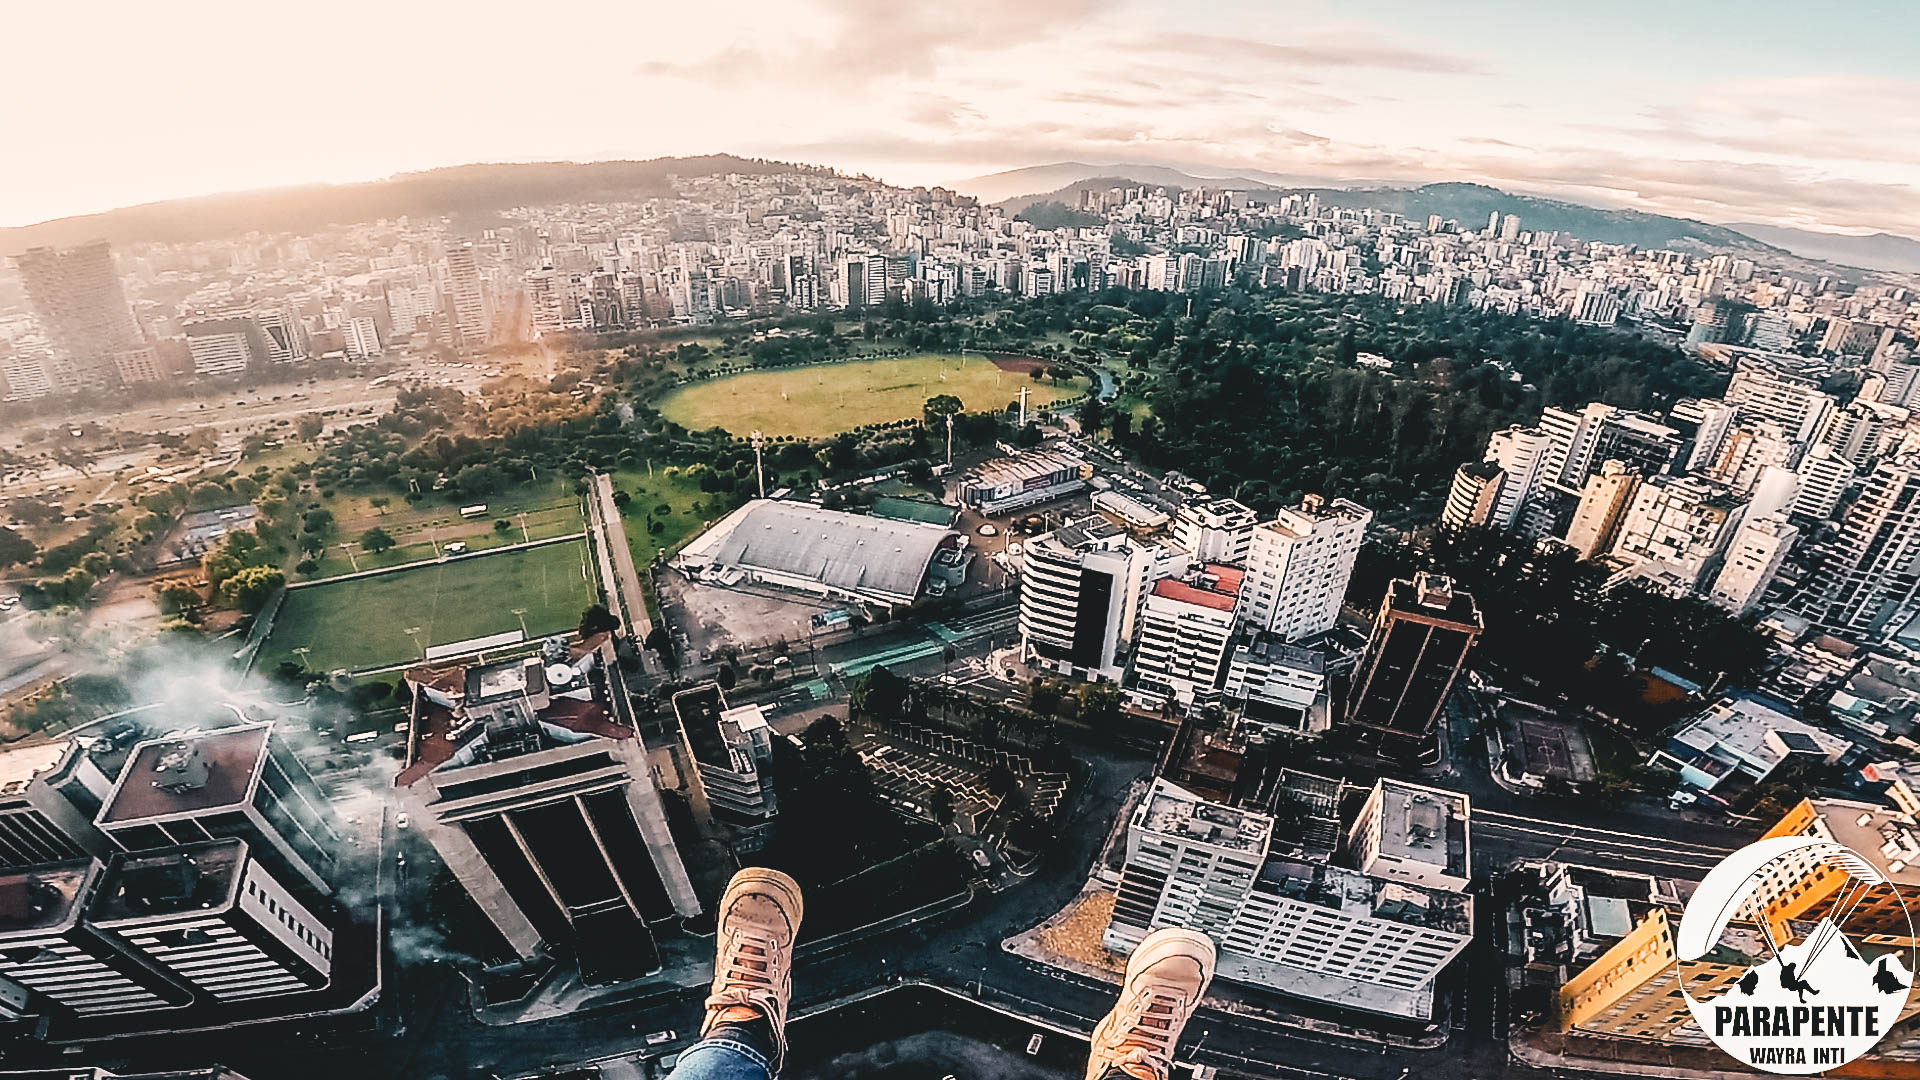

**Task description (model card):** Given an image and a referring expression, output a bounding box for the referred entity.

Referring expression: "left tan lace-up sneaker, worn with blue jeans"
[701,867,801,1072]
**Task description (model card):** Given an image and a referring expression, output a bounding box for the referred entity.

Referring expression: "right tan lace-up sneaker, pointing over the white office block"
[1087,926,1213,1080]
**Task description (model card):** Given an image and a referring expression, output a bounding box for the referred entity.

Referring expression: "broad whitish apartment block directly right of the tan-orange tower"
[1613,477,1747,596]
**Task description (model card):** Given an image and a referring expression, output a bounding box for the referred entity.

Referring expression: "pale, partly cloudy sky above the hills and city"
[0,0,1920,234]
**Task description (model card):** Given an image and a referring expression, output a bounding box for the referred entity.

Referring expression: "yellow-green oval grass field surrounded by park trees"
[659,354,1087,438]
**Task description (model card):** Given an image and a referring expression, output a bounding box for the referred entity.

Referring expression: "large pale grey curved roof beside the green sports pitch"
[712,502,954,600]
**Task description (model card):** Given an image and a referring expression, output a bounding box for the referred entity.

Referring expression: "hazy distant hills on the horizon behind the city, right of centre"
[983,161,1786,254]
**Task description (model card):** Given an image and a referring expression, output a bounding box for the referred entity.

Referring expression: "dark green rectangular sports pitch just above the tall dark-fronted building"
[259,542,595,671]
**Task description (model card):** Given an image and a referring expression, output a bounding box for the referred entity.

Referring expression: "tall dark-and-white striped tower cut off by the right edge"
[1803,455,1920,642]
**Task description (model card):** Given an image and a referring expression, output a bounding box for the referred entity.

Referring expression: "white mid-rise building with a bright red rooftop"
[1133,563,1244,705]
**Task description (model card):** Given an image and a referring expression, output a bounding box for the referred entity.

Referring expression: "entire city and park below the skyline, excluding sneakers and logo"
[11,37,1920,1080]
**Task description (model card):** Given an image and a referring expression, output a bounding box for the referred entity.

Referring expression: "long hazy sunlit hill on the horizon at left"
[0,154,828,256]
